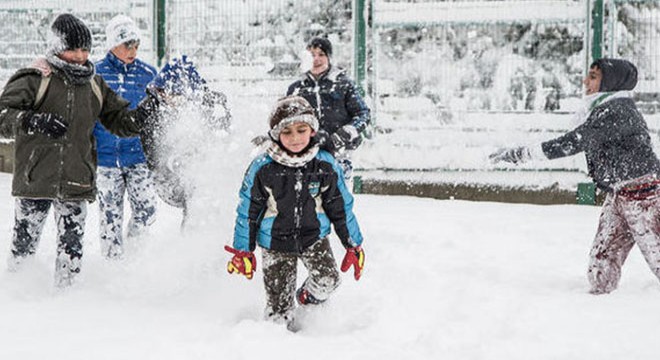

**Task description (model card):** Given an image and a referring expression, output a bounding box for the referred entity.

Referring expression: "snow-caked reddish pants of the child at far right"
[588,179,660,294]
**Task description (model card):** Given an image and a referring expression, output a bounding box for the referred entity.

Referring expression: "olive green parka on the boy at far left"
[0,68,139,201]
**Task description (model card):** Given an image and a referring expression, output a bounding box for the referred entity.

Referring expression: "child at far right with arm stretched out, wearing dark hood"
[490,59,660,294]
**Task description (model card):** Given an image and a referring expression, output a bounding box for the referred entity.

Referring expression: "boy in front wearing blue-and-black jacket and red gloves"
[225,96,364,329]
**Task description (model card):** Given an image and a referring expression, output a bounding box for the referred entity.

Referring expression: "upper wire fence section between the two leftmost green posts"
[166,0,352,87]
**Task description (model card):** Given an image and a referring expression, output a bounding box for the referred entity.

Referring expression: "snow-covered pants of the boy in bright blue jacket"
[97,164,156,258]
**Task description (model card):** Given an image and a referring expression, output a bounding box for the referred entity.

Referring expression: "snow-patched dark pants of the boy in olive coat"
[10,198,87,286]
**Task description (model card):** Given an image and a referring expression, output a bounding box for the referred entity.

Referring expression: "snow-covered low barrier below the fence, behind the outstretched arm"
[354,112,660,203]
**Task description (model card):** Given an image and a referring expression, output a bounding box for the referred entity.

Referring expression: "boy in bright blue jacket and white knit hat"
[94,15,157,259]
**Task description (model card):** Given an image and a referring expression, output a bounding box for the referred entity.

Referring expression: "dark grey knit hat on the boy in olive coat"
[49,14,92,54]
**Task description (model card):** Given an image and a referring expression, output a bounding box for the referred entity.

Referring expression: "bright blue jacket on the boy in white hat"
[94,52,158,167]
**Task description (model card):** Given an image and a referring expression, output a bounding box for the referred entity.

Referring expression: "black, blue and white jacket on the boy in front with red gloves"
[233,145,362,253]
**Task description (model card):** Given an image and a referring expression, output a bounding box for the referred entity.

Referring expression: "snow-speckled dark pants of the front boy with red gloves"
[262,237,341,322]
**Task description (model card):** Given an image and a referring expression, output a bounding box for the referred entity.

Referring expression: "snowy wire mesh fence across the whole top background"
[0,0,660,107]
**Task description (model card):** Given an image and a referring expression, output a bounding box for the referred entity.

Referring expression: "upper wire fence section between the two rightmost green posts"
[372,0,587,118]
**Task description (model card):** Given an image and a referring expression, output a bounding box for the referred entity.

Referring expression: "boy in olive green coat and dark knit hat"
[0,14,156,287]
